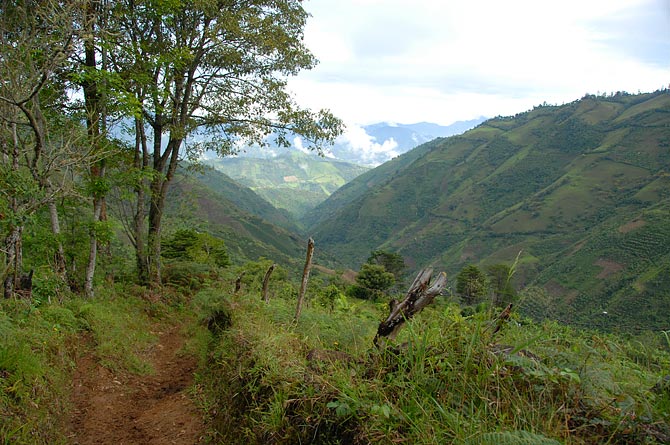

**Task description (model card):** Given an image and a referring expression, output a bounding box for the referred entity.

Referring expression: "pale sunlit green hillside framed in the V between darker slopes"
[208,151,368,217]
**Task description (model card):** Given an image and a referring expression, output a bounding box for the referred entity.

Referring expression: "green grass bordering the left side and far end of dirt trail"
[0,289,185,445]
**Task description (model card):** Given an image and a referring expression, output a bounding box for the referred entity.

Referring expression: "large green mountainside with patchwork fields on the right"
[306,91,670,329]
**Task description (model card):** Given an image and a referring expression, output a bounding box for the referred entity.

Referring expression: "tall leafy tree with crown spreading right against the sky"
[109,0,341,284]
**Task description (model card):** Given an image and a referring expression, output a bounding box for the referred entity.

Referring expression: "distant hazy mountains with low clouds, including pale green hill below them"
[205,118,484,219]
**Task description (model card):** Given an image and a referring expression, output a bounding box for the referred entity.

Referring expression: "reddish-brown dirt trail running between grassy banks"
[70,327,205,445]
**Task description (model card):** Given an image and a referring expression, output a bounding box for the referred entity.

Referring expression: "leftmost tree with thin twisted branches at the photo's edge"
[0,0,90,296]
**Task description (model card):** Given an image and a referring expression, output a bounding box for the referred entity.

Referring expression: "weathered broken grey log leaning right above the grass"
[374,269,447,347]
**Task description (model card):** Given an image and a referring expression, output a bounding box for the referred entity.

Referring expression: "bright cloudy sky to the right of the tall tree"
[289,0,670,126]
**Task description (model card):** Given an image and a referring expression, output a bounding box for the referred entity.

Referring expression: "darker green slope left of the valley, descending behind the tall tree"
[163,168,306,264]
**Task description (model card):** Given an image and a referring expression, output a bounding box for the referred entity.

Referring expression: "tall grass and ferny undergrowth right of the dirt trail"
[195,291,670,444]
